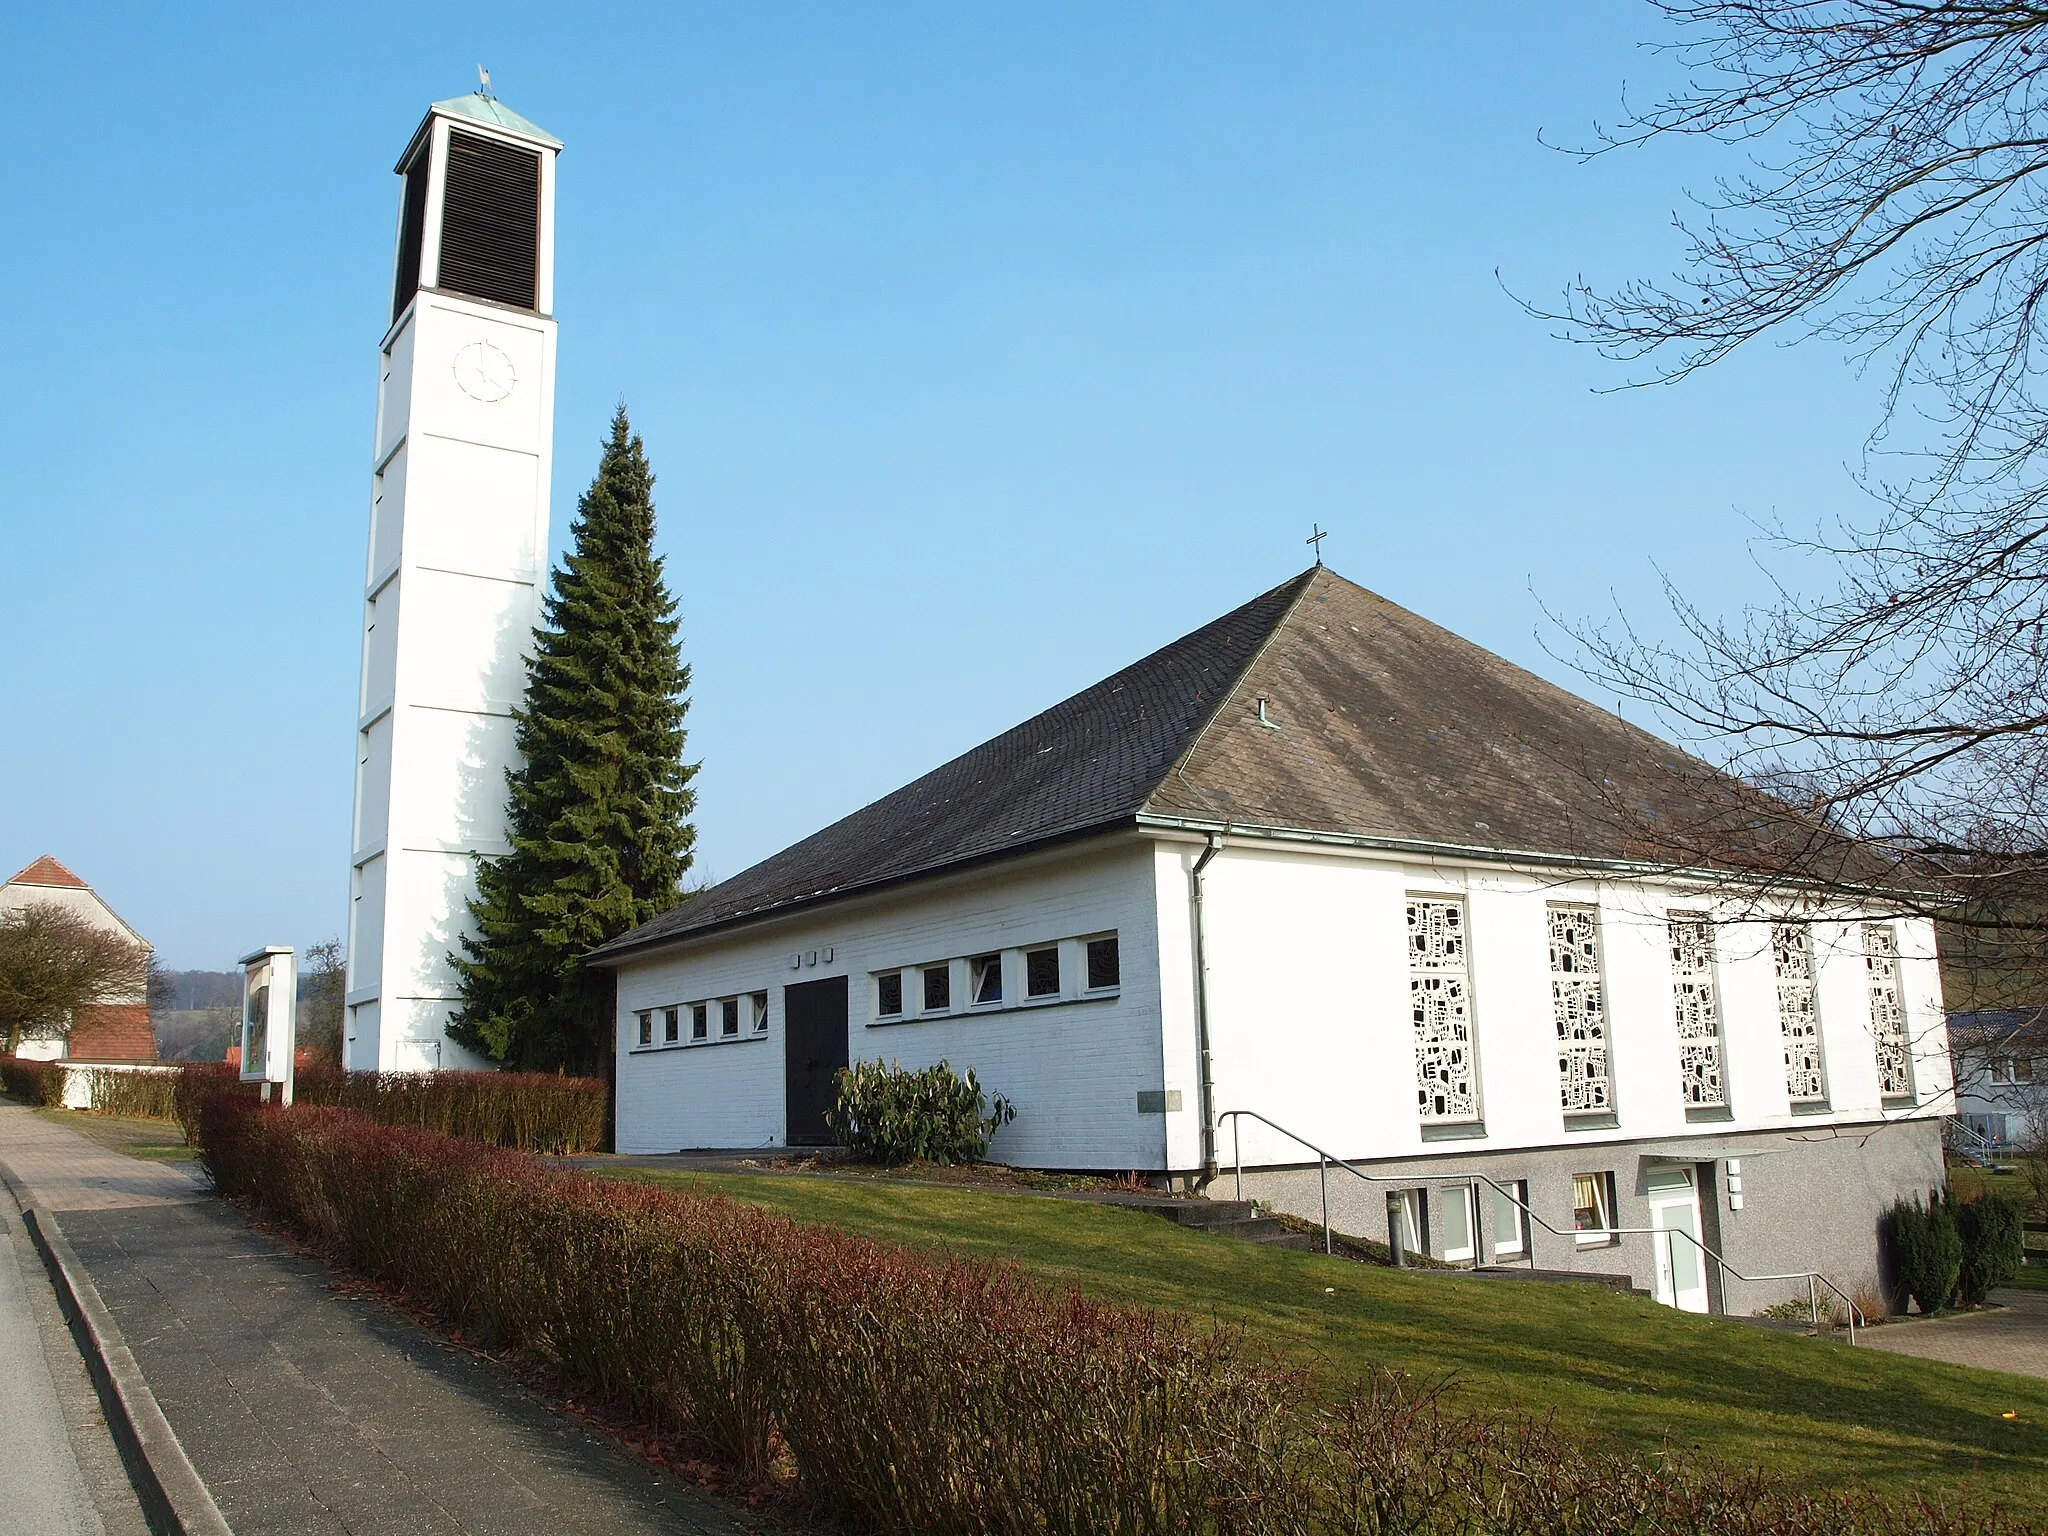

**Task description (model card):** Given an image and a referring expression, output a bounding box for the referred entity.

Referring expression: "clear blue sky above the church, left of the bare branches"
[0,0,1874,967]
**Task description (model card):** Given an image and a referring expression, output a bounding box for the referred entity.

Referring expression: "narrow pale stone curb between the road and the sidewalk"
[0,1167,233,1536]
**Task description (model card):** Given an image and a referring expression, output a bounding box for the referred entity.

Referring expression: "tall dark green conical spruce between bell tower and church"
[449,403,696,1071]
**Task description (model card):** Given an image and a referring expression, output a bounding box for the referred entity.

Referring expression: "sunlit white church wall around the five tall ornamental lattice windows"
[1179,840,1950,1167]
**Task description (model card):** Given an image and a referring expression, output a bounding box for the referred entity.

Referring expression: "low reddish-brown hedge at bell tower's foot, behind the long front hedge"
[176,1065,604,1155]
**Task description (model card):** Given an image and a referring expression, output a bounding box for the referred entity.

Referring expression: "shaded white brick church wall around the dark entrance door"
[618,842,1169,1169]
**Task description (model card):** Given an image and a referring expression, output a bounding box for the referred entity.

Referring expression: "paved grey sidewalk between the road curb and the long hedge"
[0,1104,748,1536]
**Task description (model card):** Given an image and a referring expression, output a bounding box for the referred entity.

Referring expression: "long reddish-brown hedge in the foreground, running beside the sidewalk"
[199,1096,2042,1536]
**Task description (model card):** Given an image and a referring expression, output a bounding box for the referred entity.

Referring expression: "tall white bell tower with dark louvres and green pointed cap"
[342,92,561,1071]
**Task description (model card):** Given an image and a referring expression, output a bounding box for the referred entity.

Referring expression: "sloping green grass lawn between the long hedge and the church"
[618,1169,2048,1509]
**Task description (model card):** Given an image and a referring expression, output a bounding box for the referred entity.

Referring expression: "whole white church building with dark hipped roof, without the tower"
[592,567,1954,1313]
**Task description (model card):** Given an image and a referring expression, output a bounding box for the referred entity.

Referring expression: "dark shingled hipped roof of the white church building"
[592,565,1843,963]
